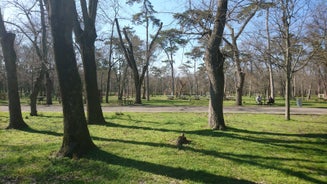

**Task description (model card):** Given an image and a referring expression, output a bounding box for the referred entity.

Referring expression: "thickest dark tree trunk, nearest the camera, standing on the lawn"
[48,0,96,157]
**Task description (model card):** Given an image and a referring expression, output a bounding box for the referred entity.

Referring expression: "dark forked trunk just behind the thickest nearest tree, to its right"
[73,0,106,124]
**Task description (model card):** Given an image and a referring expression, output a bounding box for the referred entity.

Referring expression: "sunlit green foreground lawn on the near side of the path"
[0,112,327,184]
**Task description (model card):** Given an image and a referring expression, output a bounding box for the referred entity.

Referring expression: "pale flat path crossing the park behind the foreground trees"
[0,105,327,114]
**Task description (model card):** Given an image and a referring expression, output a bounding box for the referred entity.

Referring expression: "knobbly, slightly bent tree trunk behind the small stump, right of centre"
[205,0,228,130]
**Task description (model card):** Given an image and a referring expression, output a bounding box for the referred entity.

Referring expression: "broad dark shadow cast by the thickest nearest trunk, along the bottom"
[89,149,254,184]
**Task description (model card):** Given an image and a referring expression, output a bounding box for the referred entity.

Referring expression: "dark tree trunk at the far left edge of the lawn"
[0,10,28,129]
